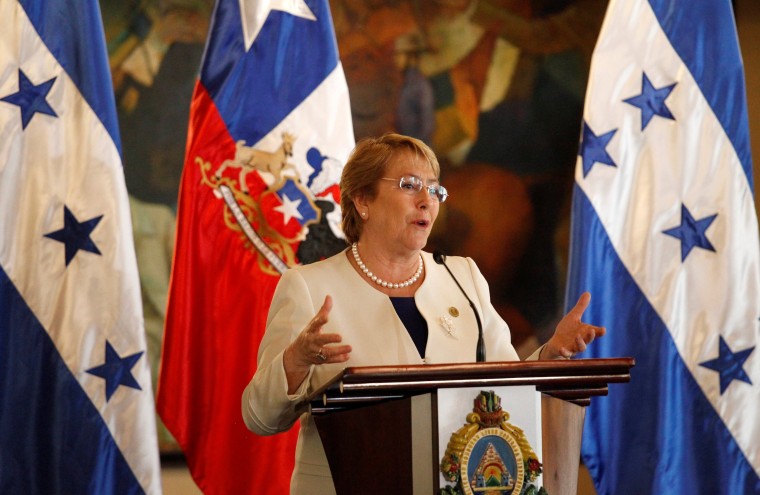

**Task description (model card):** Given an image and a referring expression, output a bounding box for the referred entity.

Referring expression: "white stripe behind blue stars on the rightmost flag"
[576,1,760,474]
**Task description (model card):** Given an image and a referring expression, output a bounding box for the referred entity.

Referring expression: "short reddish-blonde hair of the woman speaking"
[340,133,441,243]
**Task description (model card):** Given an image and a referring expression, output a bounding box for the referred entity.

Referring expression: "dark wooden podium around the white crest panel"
[306,358,634,495]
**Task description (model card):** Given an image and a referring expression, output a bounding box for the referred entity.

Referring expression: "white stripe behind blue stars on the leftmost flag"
[0,2,160,493]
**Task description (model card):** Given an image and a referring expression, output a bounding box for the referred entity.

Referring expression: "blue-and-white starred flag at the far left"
[0,0,161,494]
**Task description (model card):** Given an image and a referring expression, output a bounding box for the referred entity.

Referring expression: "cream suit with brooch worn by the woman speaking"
[242,251,533,495]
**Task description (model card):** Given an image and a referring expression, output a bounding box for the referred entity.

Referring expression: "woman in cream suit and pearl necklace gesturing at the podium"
[242,134,604,494]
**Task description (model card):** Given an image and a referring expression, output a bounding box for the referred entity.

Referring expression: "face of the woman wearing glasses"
[356,150,440,256]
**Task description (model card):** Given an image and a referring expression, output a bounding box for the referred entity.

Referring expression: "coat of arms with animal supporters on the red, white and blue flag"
[195,132,346,274]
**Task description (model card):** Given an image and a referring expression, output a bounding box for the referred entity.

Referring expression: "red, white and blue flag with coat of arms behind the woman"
[158,0,354,494]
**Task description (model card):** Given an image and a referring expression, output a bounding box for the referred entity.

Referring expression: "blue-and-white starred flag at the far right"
[567,0,760,495]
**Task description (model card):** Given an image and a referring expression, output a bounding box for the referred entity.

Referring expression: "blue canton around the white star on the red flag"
[201,0,338,143]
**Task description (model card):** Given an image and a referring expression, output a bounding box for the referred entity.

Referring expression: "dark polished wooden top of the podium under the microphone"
[304,357,635,413]
